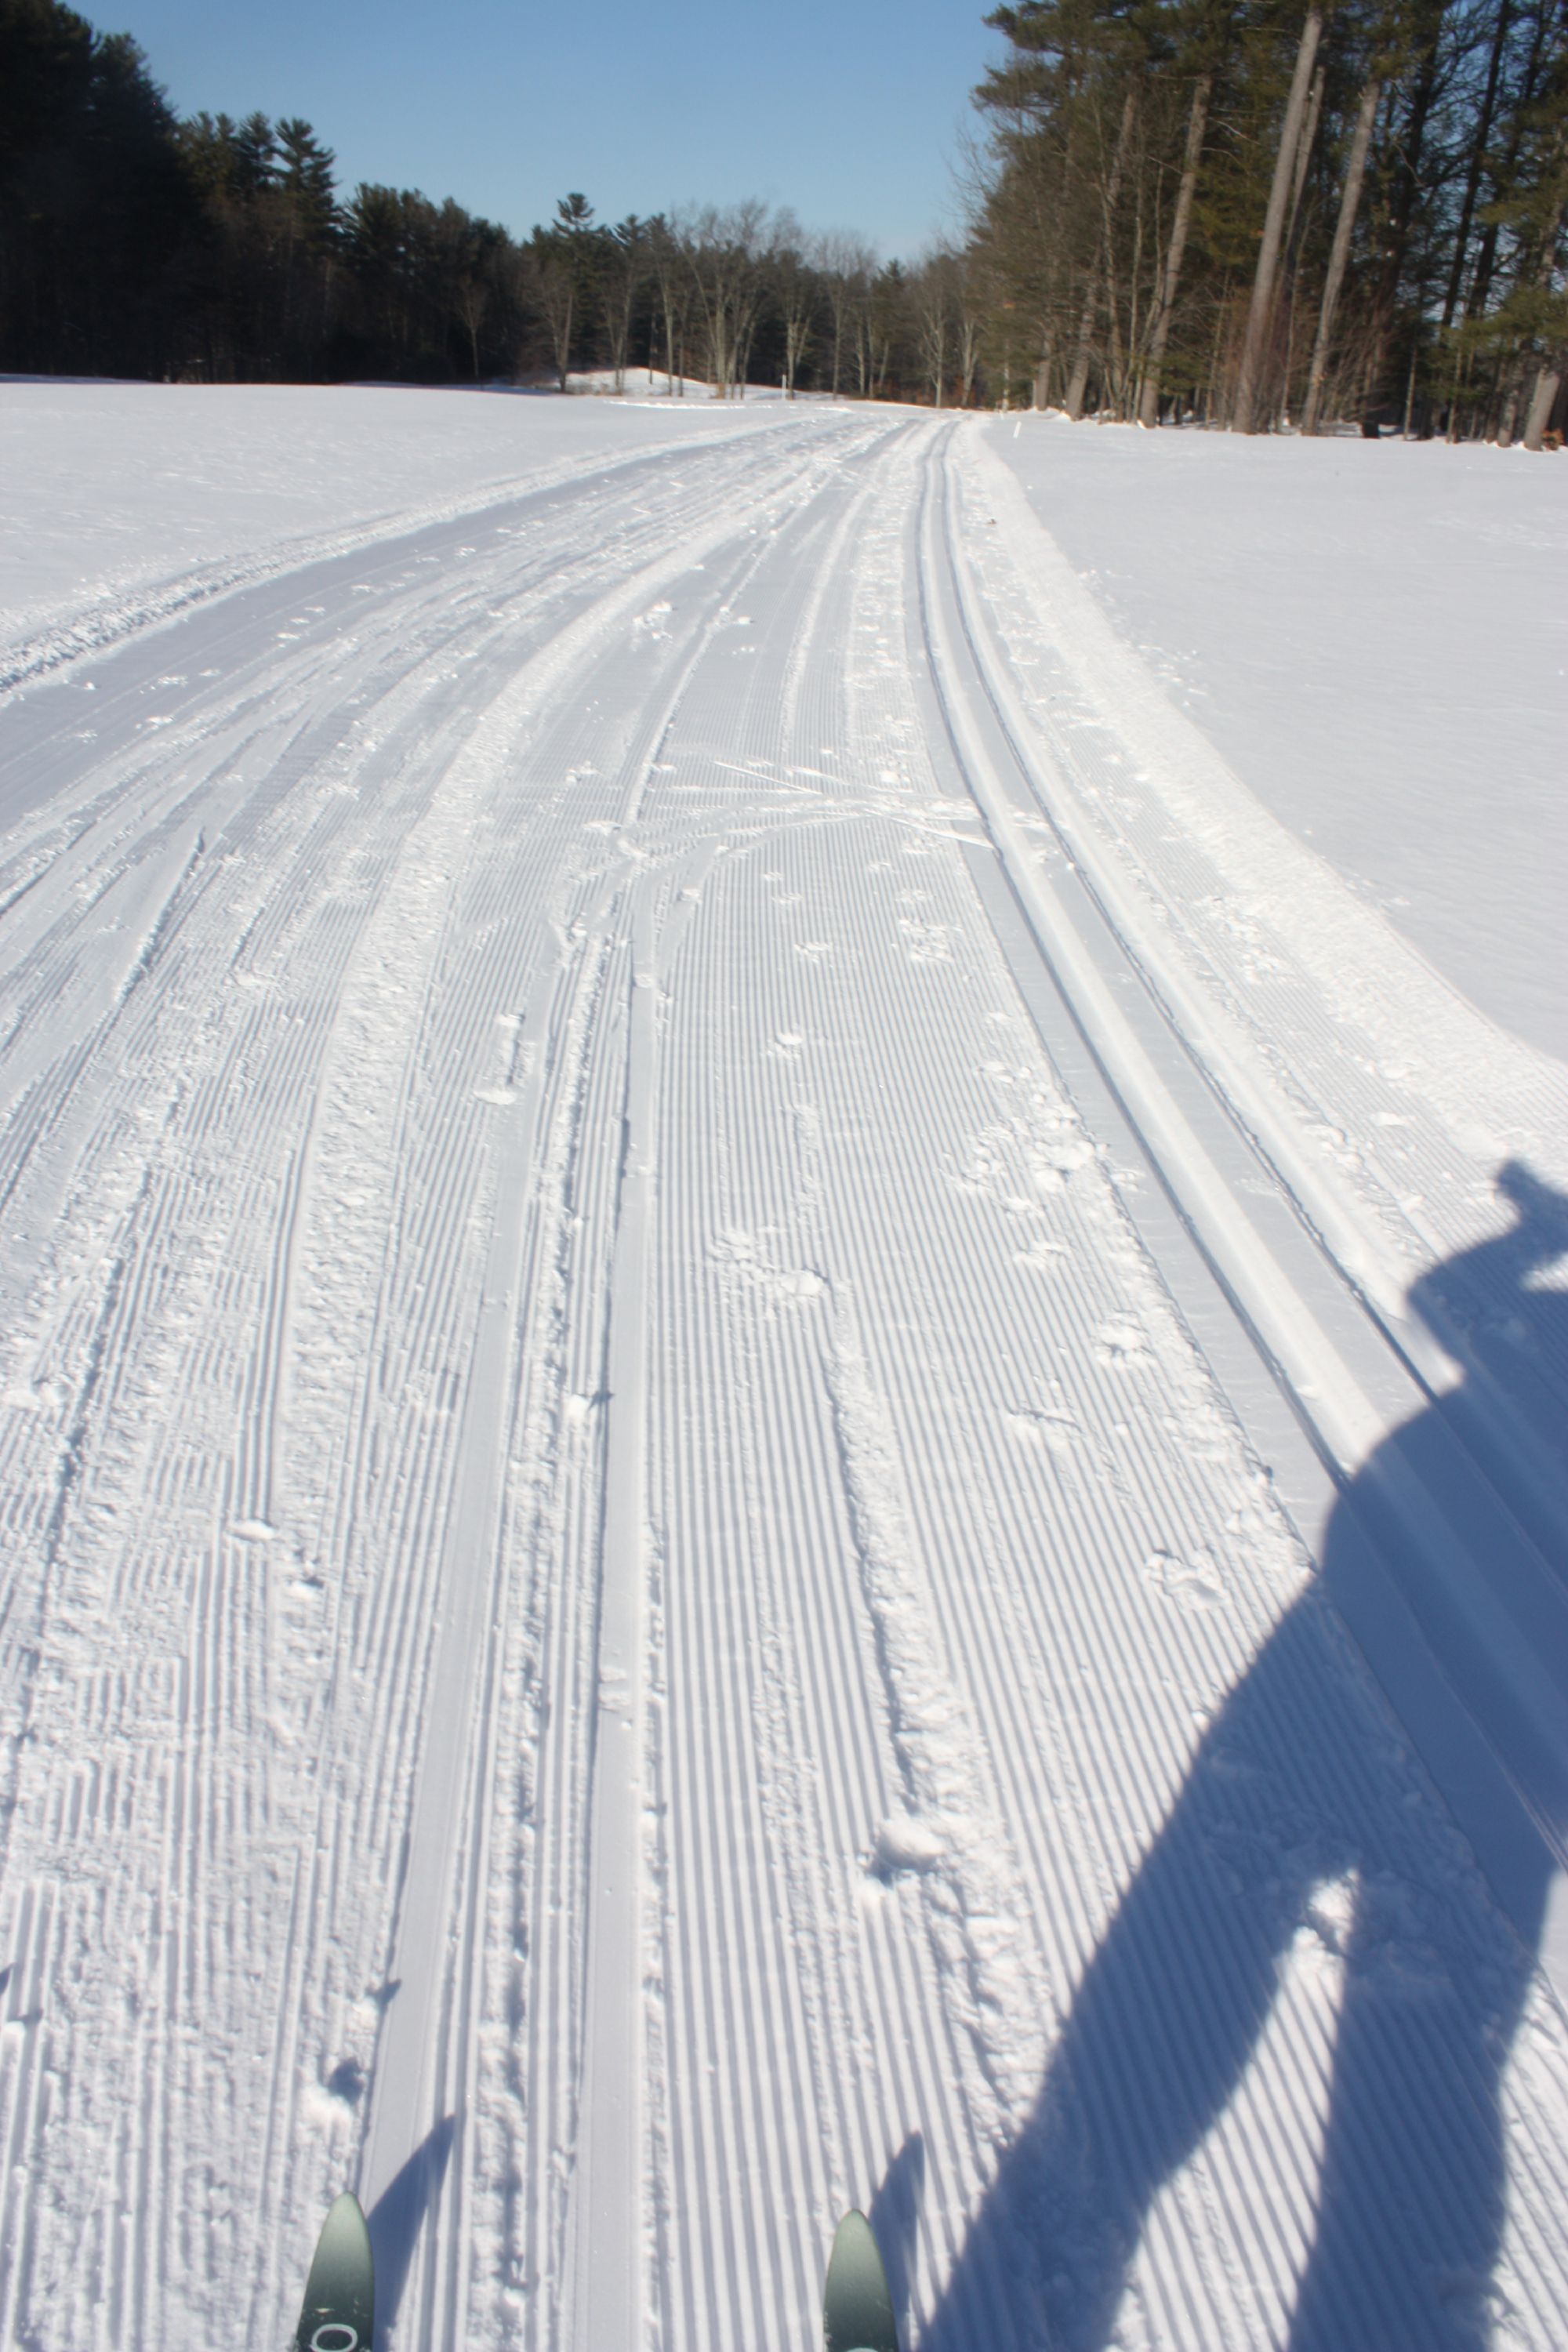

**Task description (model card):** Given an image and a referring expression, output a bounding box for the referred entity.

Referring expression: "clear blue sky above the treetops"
[103,0,999,254]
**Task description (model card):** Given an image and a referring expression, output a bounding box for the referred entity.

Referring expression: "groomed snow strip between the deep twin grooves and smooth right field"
[949,435,1568,1515]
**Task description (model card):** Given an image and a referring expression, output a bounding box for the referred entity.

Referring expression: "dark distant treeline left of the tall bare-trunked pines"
[0,0,959,400]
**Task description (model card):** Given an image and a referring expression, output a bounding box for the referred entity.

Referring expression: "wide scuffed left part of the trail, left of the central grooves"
[0,414,893,2343]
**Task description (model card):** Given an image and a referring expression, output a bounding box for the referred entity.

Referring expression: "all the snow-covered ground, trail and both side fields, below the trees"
[0,383,1568,2352]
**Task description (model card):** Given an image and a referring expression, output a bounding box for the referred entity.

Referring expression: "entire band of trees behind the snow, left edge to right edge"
[0,0,1568,447]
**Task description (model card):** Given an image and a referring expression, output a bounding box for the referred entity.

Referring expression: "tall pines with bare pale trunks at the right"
[966,0,1568,445]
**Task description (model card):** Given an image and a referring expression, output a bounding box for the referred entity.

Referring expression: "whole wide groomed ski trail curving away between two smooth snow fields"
[0,412,1568,2352]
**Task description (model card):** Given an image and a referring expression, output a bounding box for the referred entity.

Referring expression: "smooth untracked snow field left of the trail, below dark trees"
[0,369,804,677]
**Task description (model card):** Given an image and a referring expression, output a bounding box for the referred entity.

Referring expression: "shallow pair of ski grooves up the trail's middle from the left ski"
[260,423,907,2340]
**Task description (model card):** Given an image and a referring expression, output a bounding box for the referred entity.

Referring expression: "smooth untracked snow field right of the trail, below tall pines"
[992,416,1568,1056]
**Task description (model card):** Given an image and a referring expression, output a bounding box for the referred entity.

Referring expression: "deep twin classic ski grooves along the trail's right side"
[926,433,1568,1938]
